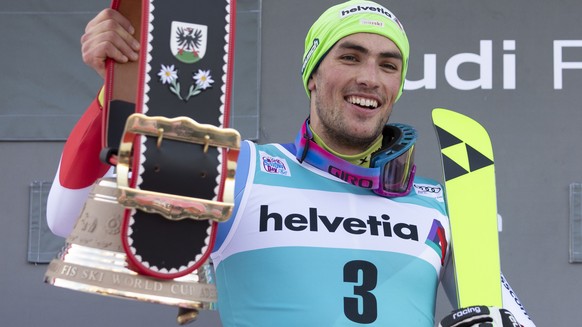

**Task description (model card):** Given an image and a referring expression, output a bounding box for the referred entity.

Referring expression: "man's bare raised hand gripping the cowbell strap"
[81,8,140,78]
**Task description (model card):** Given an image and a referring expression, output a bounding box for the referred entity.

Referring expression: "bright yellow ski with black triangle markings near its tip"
[432,108,502,308]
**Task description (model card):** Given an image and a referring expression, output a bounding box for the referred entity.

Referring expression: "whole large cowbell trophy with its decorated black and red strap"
[45,0,240,323]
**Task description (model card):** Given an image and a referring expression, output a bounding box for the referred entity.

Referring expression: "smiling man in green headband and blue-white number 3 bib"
[48,0,534,327]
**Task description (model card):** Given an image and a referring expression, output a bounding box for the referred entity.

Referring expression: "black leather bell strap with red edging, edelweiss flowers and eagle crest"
[102,0,240,279]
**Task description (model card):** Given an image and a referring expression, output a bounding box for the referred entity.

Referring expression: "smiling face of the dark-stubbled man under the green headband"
[308,33,403,154]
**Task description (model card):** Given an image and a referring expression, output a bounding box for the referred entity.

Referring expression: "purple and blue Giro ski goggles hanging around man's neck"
[295,120,416,197]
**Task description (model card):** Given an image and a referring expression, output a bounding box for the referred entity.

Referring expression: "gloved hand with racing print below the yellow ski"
[439,306,521,327]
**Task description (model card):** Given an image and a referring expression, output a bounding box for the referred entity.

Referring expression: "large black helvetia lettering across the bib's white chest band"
[259,205,418,241]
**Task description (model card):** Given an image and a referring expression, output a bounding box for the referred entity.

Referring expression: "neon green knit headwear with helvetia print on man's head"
[301,0,410,100]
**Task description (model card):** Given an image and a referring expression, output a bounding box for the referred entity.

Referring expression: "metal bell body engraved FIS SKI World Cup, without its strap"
[45,179,217,323]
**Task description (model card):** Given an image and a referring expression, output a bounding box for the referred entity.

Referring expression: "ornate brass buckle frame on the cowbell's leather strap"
[117,113,241,222]
